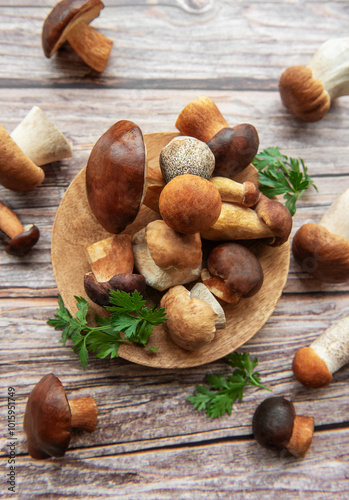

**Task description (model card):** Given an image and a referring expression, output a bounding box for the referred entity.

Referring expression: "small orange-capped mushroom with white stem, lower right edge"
[292,316,349,389]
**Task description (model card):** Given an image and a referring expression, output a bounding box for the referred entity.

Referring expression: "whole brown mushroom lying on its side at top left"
[41,0,113,72]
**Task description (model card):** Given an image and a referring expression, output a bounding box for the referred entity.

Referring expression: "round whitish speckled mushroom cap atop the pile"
[160,136,215,183]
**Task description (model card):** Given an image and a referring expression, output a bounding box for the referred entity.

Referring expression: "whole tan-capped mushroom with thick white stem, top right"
[279,38,349,122]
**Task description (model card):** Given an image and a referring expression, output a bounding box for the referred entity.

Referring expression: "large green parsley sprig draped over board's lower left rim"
[47,290,166,369]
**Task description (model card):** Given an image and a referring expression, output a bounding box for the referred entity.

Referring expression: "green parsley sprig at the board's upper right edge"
[252,147,318,215]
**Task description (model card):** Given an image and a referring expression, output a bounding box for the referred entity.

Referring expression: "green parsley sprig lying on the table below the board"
[188,352,271,418]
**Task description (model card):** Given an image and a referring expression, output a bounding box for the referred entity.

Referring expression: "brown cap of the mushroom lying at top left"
[41,0,104,57]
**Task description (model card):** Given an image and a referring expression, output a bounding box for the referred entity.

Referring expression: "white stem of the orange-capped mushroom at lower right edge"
[310,316,349,374]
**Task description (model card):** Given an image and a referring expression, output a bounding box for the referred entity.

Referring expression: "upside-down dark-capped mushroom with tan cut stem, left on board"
[84,234,146,306]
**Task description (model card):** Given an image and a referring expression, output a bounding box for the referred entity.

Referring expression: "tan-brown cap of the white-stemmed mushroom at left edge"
[0,125,45,191]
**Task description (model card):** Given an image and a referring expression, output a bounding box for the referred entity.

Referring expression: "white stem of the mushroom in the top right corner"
[307,38,349,100]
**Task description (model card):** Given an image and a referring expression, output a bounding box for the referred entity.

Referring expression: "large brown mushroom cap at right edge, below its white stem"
[292,223,349,283]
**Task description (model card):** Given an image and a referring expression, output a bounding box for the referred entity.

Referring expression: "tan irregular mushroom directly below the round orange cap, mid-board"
[132,220,202,291]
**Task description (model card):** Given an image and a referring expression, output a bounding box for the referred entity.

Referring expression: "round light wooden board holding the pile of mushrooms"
[52,132,290,368]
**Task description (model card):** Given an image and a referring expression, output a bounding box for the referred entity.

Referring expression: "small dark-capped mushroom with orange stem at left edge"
[0,202,40,257]
